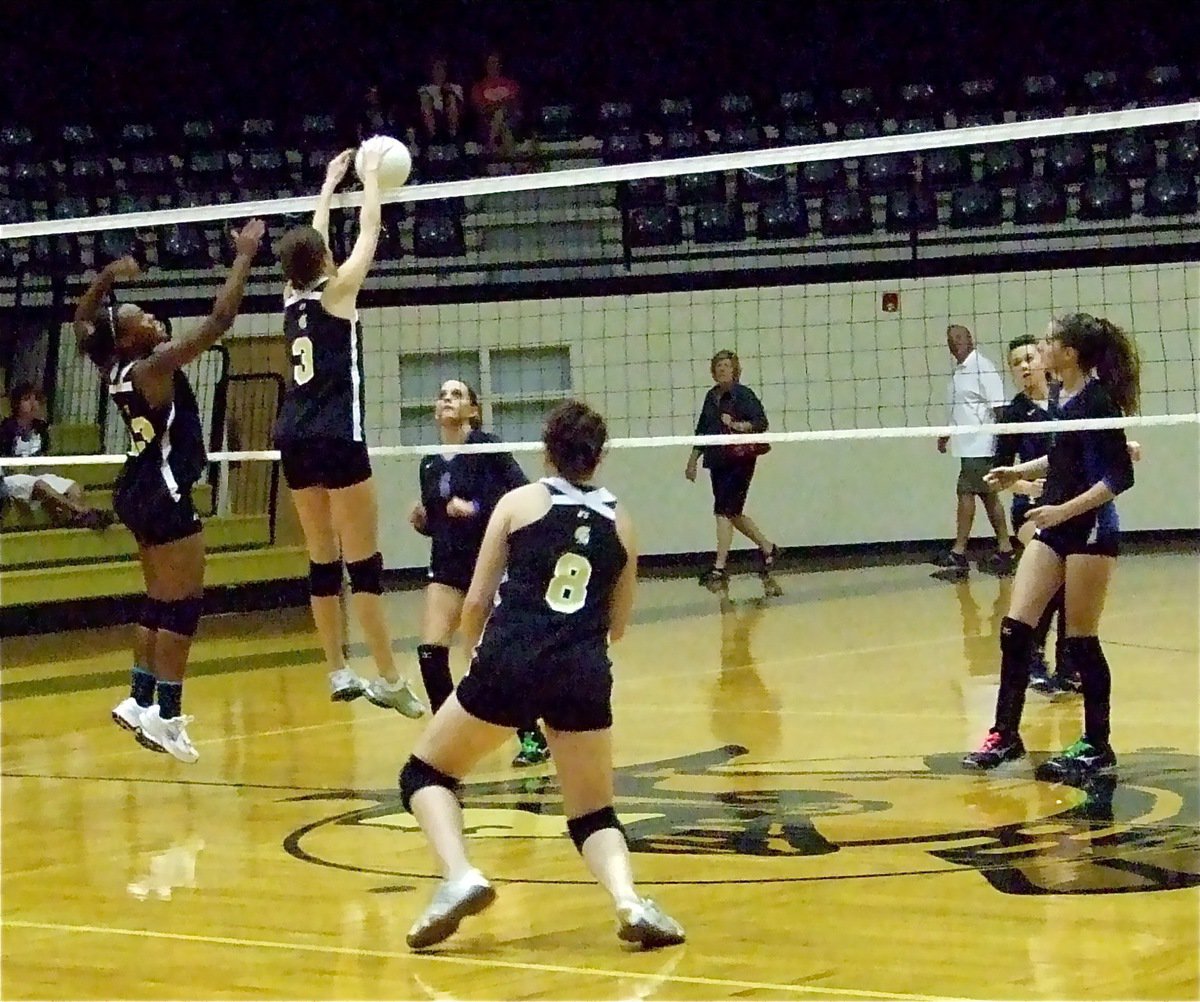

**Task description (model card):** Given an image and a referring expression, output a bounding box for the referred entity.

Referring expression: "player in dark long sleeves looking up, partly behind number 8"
[409,379,550,766]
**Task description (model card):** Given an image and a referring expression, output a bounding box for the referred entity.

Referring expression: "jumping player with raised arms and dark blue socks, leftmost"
[74,220,263,763]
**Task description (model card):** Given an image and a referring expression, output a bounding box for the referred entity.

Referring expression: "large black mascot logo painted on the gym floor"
[284,745,1200,894]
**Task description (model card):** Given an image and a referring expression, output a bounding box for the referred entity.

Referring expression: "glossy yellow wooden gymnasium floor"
[0,552,1200,1000]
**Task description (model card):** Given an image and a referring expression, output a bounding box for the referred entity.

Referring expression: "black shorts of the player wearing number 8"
[455,631,612,731]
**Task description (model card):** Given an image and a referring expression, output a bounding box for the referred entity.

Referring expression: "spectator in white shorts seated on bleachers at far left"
[0,383,114,529]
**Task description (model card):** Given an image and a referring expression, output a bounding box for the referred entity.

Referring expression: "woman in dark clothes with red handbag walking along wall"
[684,350,779,588]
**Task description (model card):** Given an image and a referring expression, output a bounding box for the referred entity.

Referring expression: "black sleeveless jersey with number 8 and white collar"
[484,476,628,660]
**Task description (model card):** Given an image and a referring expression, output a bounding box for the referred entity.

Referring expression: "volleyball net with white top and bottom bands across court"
[0,102,1200,552]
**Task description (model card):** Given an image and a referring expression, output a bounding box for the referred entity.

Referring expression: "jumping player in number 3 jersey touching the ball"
[275,150,425,716]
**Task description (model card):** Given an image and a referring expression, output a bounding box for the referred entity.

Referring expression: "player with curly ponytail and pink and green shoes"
[962,313,1140,781]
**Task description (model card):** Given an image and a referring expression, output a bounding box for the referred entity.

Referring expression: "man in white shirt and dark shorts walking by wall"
[935,324,1015,580]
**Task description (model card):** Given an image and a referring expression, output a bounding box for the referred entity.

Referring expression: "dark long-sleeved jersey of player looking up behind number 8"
[419,428,529,566]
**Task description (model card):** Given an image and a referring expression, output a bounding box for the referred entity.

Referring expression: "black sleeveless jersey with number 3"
[275,280,364,442]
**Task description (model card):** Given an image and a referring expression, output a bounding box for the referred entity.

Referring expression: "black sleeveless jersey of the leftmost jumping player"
[108,362,208,500]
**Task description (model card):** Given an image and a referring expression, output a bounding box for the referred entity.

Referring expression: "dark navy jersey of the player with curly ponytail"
[1040,379,1133,530]
